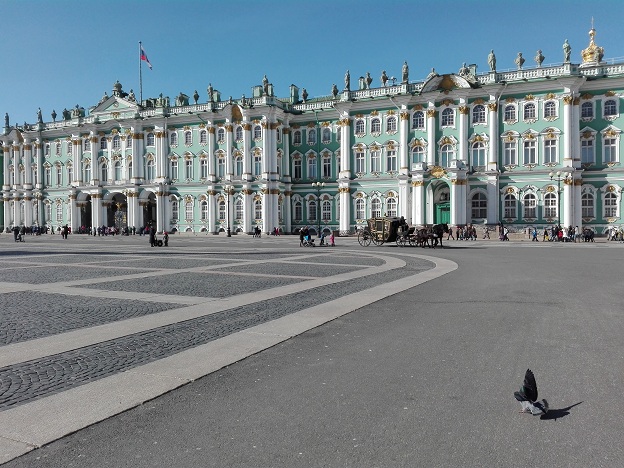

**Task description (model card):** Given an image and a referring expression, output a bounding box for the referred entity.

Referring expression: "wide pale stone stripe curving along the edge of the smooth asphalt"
[0,253,457,463]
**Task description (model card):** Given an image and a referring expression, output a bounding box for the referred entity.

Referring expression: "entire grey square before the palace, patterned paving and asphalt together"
[0,235,624,468]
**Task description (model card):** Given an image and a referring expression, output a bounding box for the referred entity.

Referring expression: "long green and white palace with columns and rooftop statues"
[0,29,624,234]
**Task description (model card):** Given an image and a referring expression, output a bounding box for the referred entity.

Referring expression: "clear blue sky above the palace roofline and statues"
[0,0,624,125]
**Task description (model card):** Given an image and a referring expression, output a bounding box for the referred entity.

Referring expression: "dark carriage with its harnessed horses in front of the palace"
[358,217,448,247]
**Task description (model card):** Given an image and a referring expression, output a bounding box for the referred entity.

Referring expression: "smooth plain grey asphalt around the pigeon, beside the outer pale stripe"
[4,242,624,468]
